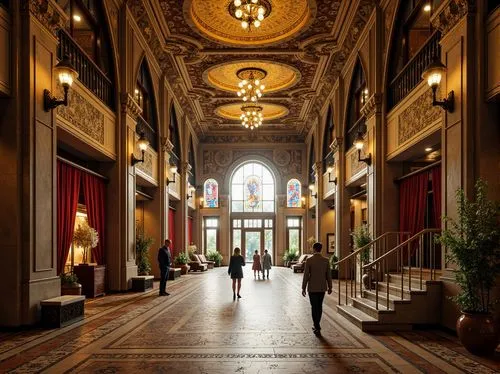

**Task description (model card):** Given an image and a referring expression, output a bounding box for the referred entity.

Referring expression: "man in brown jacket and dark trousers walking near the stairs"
[302,243,332,335]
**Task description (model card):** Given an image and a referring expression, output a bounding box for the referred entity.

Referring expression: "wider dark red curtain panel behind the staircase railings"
[399,173,429,241]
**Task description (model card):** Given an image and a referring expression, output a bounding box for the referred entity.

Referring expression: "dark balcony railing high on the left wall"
[57,30,115,111]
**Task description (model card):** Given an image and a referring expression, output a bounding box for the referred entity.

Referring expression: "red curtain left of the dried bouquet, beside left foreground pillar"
[57,161,82,274]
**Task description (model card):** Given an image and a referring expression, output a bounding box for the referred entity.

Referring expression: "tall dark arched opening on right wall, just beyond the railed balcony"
[345,59,368,149]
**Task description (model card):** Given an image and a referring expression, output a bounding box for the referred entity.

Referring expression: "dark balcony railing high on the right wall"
[388,31,441,109]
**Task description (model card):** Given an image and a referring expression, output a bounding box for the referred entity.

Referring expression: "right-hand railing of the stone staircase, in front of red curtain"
[363,229,441,309]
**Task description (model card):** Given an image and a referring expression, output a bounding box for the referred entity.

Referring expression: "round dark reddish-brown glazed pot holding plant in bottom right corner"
[457,312,498,356]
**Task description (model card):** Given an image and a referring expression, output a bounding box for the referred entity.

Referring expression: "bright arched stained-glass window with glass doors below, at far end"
[230,161,276,261]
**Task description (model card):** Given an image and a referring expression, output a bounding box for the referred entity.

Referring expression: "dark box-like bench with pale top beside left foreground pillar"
[40,295,85,328]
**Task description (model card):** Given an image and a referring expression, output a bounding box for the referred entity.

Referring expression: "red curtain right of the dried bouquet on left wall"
[83,173,106,265]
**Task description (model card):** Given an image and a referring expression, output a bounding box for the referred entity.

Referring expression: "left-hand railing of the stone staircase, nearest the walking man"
[333,231,410,305]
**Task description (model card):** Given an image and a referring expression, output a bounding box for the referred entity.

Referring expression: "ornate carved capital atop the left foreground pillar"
[21,0,68,38]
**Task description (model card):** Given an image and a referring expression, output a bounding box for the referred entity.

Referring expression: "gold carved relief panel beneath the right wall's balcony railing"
[398,88,441,145]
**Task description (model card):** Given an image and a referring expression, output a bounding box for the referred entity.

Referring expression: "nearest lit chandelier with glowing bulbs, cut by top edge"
[229,0,271,31]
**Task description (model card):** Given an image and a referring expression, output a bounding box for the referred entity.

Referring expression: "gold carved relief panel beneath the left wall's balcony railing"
[57,84,104,145]
